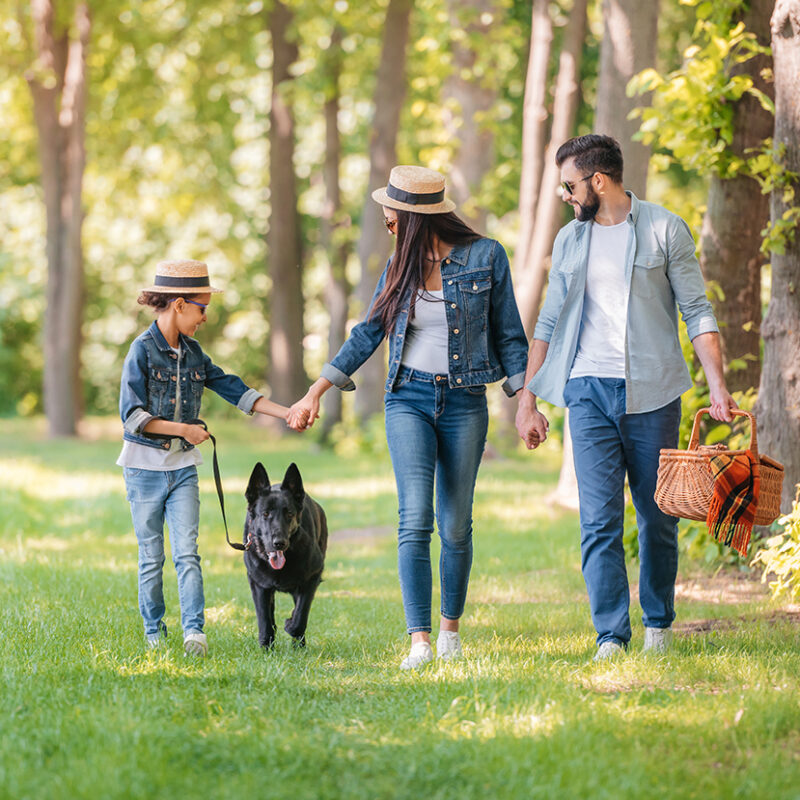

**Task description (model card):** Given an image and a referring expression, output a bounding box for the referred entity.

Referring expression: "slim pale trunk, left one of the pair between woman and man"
[514,0,553,276]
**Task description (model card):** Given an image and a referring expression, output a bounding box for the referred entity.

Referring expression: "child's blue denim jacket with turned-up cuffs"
[119,322,262,450]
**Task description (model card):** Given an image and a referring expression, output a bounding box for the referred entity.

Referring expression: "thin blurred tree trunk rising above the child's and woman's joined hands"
[320,26,350,441]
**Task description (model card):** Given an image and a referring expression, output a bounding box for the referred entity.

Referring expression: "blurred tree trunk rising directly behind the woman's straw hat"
[444,0,497,233]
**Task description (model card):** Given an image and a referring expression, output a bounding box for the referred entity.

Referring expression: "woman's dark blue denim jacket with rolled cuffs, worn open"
[321,239,528,397]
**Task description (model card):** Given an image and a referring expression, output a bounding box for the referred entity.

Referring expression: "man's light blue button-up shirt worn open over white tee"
[528,192,719,414]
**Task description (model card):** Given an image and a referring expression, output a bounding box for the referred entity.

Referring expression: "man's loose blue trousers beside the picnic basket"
[564,378,681,645]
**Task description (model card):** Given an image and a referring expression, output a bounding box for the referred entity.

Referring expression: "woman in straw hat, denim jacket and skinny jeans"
[289,166,527,669]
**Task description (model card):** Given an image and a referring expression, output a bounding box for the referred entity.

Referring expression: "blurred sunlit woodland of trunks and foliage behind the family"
[0,0,800,506]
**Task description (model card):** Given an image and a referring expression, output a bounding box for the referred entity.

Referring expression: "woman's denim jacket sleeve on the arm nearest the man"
[489,242,528,397]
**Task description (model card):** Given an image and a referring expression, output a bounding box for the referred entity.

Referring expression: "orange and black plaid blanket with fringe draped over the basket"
[706,450,760,556]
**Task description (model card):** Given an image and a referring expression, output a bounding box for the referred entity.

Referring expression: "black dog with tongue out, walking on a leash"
[244,462,328,647]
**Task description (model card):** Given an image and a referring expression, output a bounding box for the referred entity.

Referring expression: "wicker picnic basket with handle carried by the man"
[655,408,783,525]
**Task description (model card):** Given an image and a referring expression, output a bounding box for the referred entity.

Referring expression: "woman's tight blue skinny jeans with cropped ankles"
[384,367,489,633]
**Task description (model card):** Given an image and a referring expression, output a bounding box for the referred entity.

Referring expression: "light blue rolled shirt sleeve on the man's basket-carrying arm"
[667,216,719,339]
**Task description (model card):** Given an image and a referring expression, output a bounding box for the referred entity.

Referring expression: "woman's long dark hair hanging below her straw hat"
[370,210,482,333]
